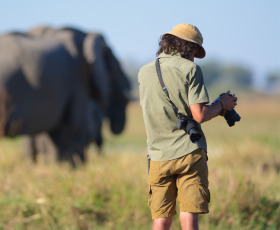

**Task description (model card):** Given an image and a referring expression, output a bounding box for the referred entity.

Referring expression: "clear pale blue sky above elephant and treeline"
[0,0,280,87]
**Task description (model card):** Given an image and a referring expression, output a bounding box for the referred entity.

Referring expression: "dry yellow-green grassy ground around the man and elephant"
[0,92,280,230]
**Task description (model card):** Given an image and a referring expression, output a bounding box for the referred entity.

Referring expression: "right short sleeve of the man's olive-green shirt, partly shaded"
[188,66,209,105]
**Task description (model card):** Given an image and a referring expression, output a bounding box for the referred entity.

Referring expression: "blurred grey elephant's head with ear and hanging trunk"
[83,33,130,134]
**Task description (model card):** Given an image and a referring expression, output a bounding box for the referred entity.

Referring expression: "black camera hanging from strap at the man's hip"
[176,115,201,143]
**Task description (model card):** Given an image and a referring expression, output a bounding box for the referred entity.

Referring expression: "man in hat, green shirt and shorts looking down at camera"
[138,24,237,230]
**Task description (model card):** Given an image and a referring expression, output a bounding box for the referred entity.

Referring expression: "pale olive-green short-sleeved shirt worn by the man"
[138,53,209,161]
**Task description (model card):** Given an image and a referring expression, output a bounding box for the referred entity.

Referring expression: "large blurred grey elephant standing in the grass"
[0,27,130,165]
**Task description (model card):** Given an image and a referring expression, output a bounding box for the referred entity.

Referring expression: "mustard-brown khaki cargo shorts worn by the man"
[148,149,210,219]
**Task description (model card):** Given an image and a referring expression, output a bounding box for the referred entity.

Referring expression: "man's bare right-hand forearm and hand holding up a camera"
[190,91,237,123]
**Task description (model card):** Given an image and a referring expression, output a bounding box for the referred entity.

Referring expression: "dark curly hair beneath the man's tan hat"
[156,34,198,59]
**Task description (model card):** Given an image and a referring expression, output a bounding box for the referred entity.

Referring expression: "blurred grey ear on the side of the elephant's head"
[83,33,111,109]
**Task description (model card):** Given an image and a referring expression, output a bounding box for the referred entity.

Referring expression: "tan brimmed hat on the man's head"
[165,23,206,58]
